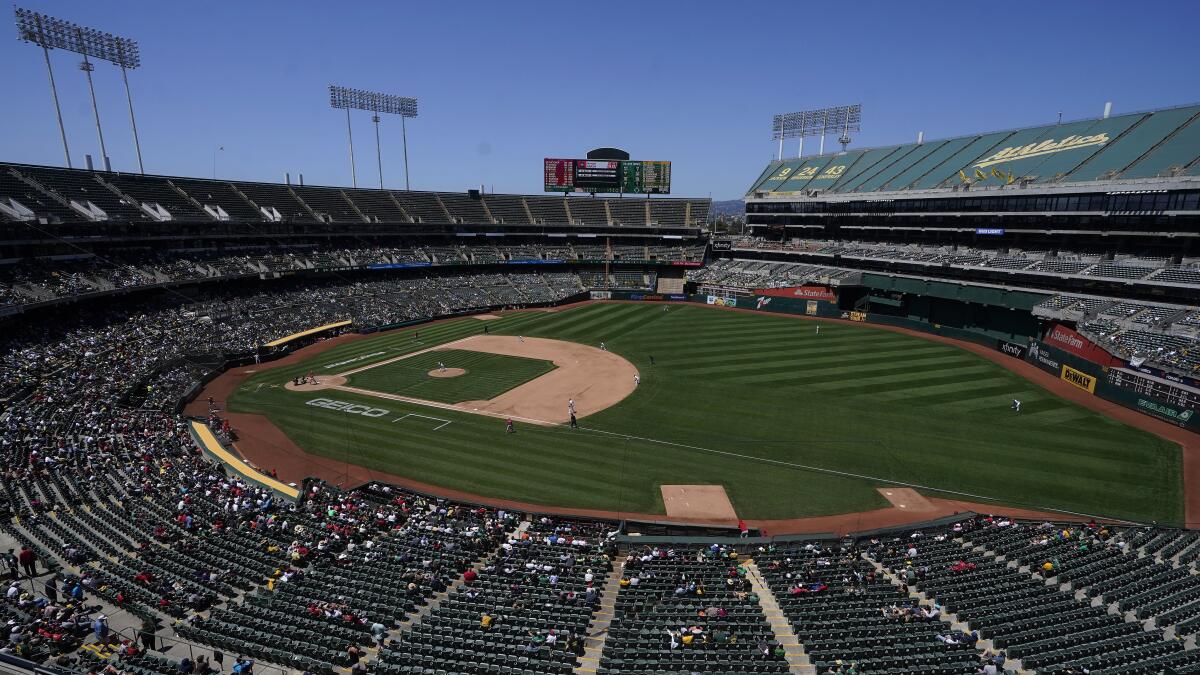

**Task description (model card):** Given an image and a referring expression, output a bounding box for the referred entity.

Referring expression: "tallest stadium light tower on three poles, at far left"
[13,7,145,173]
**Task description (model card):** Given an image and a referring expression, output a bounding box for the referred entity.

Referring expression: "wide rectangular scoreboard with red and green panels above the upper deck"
[545,157,671,195]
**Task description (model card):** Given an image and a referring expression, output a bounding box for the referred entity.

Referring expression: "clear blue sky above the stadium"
[0,0,1200,199]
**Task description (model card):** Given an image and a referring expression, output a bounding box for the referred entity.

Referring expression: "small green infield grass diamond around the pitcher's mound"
[347,350,554,404]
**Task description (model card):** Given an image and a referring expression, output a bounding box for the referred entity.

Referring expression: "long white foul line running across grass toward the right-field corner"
[334,386,1145,525]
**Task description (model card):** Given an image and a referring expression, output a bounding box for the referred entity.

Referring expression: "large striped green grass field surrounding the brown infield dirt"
[230,304,1182,522]
